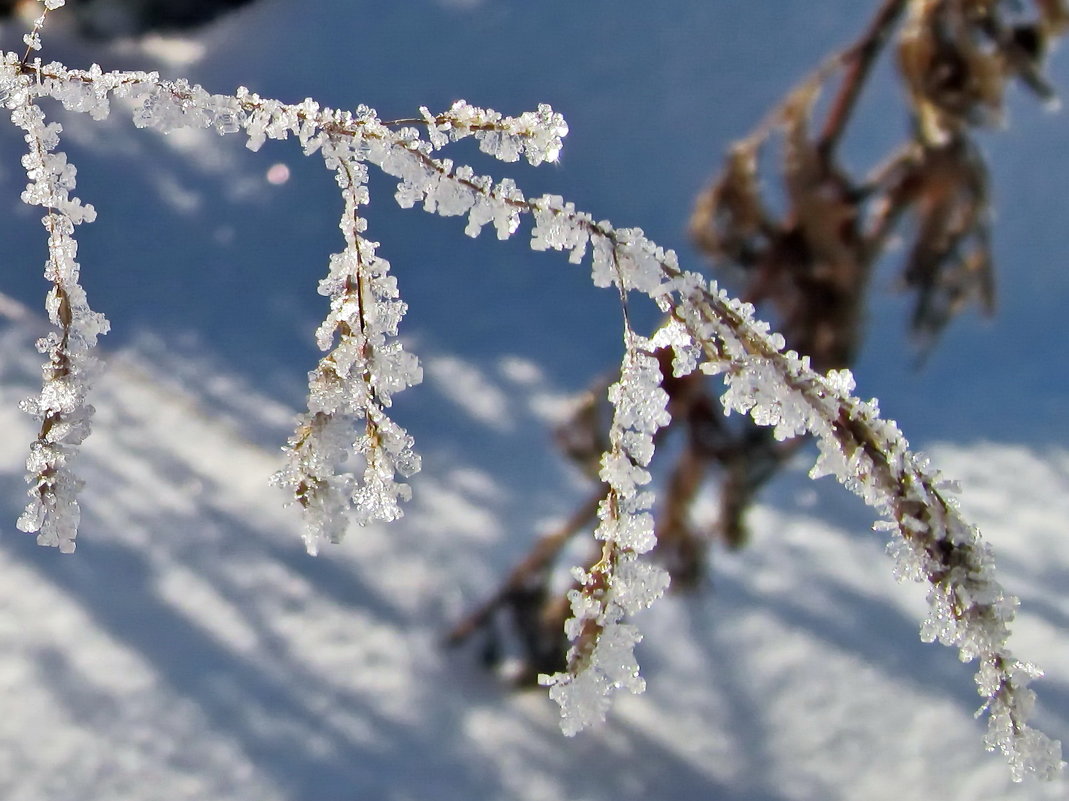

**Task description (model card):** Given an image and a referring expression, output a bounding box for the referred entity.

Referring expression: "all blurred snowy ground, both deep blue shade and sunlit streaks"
[0,0,1069,801]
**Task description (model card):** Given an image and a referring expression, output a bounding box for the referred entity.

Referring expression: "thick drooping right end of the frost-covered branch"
[675,287,1064,781]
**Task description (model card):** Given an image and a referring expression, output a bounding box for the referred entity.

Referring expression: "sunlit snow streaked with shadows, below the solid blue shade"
[0,295,1069,801]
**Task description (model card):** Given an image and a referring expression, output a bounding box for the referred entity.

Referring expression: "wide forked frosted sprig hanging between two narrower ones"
[275,137,422,553]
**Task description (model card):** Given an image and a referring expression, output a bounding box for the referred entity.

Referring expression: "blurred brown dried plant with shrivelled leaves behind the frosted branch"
[448,0,1069,684]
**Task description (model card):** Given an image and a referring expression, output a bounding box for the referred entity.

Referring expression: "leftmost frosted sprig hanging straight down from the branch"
[6,59,108,553]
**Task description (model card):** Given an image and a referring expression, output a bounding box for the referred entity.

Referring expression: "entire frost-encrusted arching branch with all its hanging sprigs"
[0,0,1063,780]
